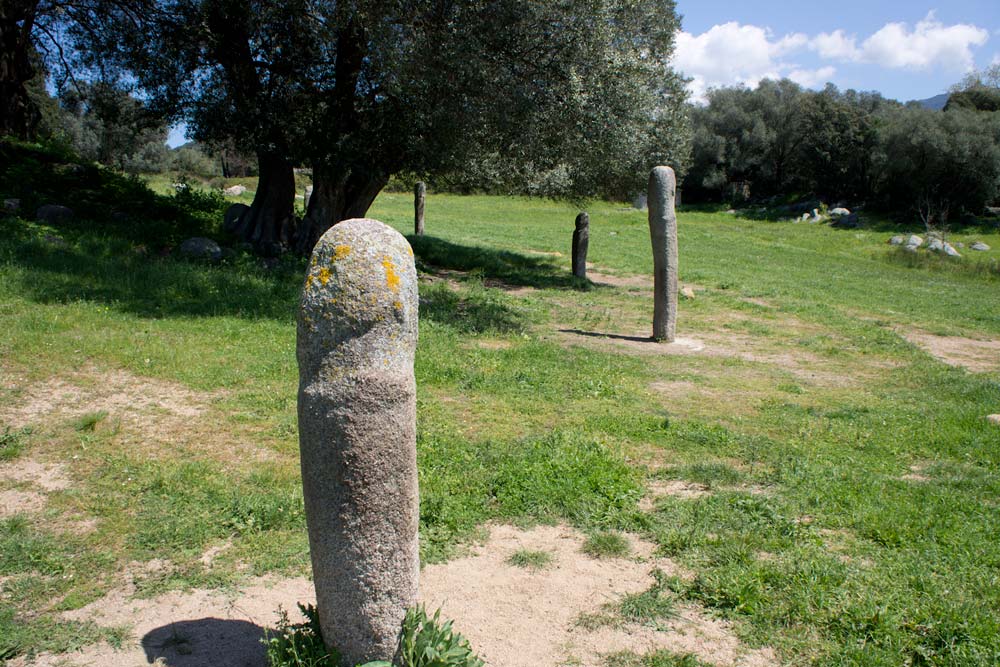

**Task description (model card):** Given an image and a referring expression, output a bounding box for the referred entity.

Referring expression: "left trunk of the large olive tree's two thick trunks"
[234,151,295,257]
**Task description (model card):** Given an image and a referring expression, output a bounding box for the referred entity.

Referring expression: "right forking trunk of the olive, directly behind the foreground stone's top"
[295,162,389,255]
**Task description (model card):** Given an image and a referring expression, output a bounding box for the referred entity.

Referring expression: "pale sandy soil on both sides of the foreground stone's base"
[19,526,778,667]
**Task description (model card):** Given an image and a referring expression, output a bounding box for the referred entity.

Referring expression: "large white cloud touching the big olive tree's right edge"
[673,22,834,101]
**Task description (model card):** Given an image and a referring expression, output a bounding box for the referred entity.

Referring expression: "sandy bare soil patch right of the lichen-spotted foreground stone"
[421,526,777,667]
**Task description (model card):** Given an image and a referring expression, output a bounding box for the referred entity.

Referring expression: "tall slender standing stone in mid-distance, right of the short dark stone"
[649,167,677,343]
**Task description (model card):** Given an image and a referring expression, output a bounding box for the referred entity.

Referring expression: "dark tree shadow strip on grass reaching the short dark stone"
[407,236,591,290]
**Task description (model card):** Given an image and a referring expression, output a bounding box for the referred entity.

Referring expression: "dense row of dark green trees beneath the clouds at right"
[684,74,1000,226]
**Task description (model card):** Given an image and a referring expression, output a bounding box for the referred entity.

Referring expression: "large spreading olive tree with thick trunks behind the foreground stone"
[0,0,687,252]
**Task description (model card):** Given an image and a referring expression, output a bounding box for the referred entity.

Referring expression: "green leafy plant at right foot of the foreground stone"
[399,605,484,667]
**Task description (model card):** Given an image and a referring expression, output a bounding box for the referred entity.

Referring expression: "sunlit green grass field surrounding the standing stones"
[0,146,1000,666]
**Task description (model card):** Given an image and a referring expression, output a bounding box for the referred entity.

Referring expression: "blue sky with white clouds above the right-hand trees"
[674,0,1000,101]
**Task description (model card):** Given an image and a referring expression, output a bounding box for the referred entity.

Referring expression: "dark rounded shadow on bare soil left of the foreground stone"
[142,618,267,667]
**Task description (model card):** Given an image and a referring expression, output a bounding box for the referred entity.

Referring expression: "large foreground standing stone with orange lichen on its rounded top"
[297,219,420,667]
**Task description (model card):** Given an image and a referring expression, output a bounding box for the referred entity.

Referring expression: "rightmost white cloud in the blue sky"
[809,12,990,71]
